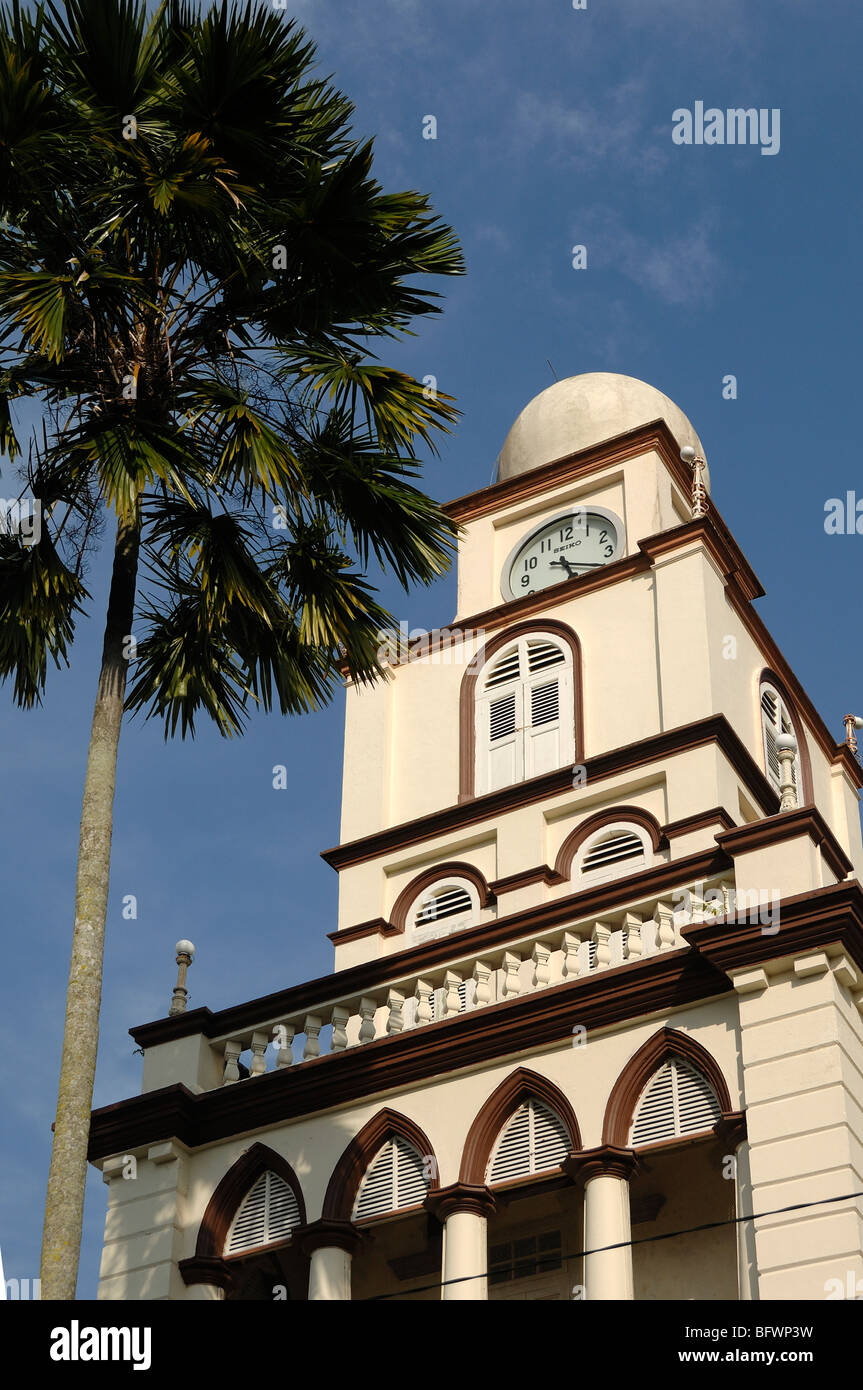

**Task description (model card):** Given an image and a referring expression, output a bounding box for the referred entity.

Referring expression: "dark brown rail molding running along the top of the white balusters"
[129,834,733,1045]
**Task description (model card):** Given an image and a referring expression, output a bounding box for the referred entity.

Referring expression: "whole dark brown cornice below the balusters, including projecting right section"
[95,881,863,1162]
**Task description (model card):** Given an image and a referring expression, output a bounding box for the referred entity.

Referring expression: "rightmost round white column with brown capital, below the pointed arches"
[577,1145,635,1302]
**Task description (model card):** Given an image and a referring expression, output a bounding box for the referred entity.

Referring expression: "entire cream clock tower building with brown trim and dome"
[92,373,863,1301]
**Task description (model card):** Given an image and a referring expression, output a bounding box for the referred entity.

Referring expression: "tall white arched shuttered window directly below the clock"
[475,632,575,795]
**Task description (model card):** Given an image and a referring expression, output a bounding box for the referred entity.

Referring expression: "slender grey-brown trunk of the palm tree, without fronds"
[42,514,140,1300]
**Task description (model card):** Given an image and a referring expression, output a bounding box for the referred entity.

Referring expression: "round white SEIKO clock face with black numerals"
[500,506,624,599]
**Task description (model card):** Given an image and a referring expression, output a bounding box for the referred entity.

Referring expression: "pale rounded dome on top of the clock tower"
[498,371,710,487]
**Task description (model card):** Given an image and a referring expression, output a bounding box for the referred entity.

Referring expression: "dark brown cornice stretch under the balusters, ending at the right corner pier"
[89,945,728,1162]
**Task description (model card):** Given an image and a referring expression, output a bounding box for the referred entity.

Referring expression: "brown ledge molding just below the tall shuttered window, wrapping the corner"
[321,714,780,870]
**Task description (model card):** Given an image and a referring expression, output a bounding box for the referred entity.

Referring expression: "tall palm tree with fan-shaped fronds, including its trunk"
[0,0,463,1300]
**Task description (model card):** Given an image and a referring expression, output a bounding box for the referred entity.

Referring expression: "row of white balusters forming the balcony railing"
[211,884,721,1086]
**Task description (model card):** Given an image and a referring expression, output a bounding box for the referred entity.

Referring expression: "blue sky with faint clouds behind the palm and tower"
[0,0,863,1297]
